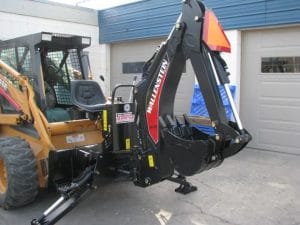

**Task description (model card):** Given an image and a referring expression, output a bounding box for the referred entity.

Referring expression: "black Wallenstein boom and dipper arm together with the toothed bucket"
[135,0,251,186]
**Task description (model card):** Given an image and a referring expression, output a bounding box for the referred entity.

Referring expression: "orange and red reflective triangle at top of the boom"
[202,10,231,52]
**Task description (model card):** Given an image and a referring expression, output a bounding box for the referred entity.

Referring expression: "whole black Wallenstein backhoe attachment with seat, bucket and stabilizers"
[32,0,251,225]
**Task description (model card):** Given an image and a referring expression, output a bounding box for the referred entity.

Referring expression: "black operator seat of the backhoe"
[71,80,106,112]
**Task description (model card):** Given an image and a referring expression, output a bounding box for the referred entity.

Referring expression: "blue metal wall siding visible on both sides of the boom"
[99,0,300,43]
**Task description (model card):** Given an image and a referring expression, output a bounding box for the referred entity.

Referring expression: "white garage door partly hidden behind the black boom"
[110,39,195,114]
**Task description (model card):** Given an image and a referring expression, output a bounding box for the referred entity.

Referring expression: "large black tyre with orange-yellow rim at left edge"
[0,138,38,209]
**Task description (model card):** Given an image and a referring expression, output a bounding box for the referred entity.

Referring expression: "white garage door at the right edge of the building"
[241,26,300,154]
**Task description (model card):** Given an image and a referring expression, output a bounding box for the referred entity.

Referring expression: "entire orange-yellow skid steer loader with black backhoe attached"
[0,0,251,225]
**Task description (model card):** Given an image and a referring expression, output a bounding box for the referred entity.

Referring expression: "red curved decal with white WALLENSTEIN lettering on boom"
[146,59,169,144]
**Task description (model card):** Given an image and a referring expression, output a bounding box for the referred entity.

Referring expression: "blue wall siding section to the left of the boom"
[99,0,181,43]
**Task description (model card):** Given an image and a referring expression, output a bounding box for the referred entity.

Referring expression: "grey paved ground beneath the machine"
[0,149,300,225]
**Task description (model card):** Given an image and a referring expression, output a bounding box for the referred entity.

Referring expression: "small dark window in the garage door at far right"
[261,56,300,73]
